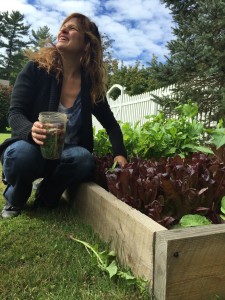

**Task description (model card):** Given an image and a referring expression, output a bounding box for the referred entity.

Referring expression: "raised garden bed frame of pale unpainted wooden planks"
[66,183,225,300]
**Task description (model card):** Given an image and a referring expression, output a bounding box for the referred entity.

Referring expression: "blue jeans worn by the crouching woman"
[3,140,95,208]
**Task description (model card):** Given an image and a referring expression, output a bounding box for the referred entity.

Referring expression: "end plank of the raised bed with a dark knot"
[153,224,225,300]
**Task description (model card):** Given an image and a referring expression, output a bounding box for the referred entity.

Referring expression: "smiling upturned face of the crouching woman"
[56,18,85,54]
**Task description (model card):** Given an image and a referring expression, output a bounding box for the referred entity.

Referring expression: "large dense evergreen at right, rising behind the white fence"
[151,0,225,122]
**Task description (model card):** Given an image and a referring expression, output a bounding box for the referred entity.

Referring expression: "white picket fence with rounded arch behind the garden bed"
[93,84,175,131]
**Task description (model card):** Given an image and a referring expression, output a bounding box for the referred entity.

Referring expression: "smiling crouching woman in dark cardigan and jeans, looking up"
[0,13,127,218]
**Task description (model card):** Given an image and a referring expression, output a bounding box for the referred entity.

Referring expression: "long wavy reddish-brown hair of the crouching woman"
[26,13,107,103]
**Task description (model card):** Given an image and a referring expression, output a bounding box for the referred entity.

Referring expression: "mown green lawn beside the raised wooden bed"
[0,135,150,300]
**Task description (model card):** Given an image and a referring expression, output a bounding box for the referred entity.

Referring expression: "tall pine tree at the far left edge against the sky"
[0,11,30,83]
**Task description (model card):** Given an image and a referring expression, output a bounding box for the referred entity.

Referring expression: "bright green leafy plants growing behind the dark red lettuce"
[94,102,213,159]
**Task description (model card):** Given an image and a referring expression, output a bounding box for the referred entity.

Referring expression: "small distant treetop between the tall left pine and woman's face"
[30,25,56,51]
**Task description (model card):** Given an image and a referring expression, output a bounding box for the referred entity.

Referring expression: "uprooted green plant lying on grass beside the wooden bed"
[70,236,148,293]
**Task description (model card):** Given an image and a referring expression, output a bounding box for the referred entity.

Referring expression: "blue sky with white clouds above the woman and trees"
[0,0,173,65]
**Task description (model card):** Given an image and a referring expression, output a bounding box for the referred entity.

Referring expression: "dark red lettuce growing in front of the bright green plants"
[95,153,225,228]
